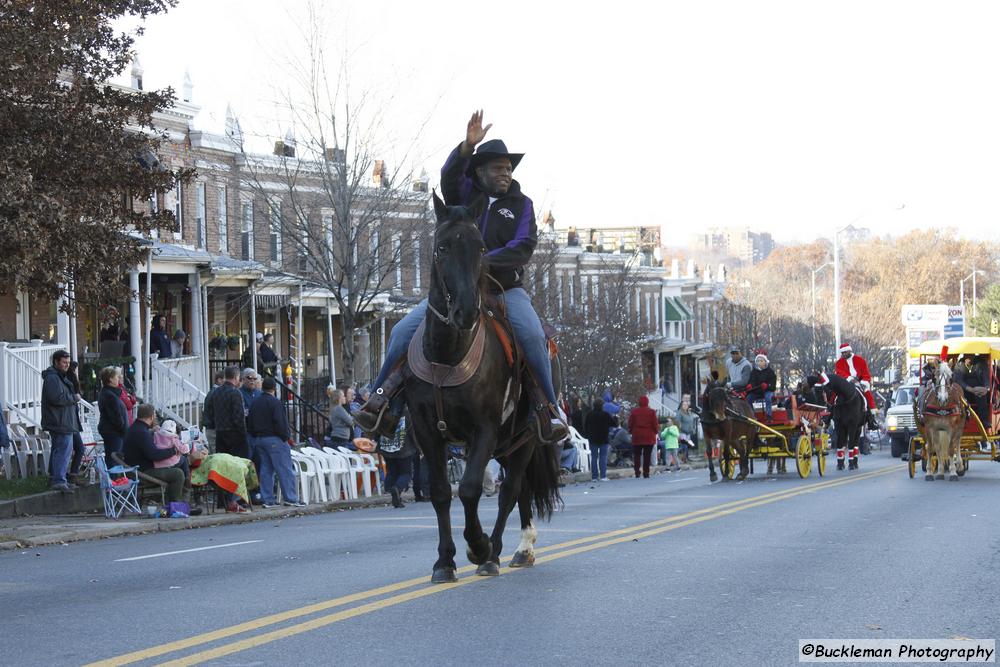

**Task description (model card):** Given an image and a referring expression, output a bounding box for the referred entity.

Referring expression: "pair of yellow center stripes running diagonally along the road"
[90,465,902,667]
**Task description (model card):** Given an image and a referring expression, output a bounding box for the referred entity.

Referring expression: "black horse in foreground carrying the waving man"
[405,193,561,583]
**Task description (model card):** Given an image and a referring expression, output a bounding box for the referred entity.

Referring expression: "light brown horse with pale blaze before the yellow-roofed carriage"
[917,361,966,482]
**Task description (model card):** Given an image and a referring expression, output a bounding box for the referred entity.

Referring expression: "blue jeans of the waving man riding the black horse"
[375,287,556,405]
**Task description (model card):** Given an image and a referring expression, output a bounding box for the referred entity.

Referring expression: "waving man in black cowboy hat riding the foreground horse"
[354,110,569,442]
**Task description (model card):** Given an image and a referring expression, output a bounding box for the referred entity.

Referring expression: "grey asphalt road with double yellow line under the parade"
[0,450,1000,666]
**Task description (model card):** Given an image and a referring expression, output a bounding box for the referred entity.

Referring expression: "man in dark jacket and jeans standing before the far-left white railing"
[42,350,81,491]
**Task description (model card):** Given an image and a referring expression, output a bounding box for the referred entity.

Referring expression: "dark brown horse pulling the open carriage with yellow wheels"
[701,386,758,482]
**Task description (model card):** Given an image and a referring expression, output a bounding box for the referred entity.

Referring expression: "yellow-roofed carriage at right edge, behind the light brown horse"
[908,338,1000,477]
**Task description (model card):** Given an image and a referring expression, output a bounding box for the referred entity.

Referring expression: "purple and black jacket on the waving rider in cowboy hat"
[441,144,538,290]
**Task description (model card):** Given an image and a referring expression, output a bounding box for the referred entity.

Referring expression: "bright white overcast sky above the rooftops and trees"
[119,0,1000,244]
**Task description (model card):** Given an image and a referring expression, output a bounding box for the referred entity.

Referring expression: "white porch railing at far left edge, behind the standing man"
[0,340,63,429]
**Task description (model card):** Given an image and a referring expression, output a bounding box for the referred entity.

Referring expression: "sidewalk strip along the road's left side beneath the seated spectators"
[0,460,705,551]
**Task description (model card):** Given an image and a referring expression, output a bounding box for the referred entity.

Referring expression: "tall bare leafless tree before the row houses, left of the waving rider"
[236,7,433,383]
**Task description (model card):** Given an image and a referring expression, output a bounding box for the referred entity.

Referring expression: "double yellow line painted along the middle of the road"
[88,465,902,667]
